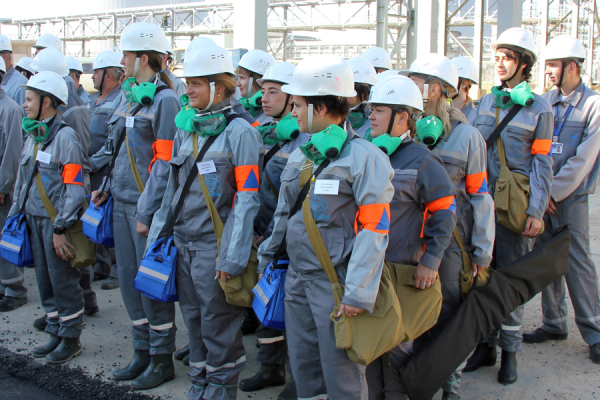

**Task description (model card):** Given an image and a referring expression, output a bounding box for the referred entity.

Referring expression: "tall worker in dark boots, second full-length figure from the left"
[92,22,180,390]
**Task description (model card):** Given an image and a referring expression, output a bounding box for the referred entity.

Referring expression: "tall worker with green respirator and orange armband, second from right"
[464,28,553,385]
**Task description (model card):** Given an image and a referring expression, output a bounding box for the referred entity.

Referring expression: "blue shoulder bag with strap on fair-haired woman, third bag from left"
[133,135,218,302]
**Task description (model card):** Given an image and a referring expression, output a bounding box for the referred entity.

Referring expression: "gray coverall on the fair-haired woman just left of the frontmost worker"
[148,99,263,400]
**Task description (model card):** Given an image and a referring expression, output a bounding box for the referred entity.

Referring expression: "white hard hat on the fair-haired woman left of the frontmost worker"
[181,46,235,78]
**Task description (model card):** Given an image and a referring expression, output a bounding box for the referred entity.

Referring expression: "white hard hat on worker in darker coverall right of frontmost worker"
[368,75,423,112]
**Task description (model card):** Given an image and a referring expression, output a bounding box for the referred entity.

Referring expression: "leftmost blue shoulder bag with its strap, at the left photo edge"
[0,141,54,267]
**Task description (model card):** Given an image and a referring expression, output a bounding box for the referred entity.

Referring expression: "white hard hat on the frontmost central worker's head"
[281,54,356,97]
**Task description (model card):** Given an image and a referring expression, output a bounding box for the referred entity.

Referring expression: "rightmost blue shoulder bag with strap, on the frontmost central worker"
[252,160,330,331]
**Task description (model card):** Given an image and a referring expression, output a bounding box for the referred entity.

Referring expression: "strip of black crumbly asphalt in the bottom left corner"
[0,347,160,400]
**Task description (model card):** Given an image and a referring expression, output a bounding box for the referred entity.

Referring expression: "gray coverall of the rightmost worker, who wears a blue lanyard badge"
[535,82,600,346]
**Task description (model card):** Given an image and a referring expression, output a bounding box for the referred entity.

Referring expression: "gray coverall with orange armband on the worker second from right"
[475,94,553,352]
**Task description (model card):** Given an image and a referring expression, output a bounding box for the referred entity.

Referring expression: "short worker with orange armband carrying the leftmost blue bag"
[9,72,85,363]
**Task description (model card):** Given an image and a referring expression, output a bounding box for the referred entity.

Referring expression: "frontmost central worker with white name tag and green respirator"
[259,55,394,400]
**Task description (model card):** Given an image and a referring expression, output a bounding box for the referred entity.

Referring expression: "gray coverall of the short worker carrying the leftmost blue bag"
[9,113,86,338]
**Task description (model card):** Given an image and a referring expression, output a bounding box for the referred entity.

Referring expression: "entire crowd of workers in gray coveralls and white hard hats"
[0,23,600,400]
